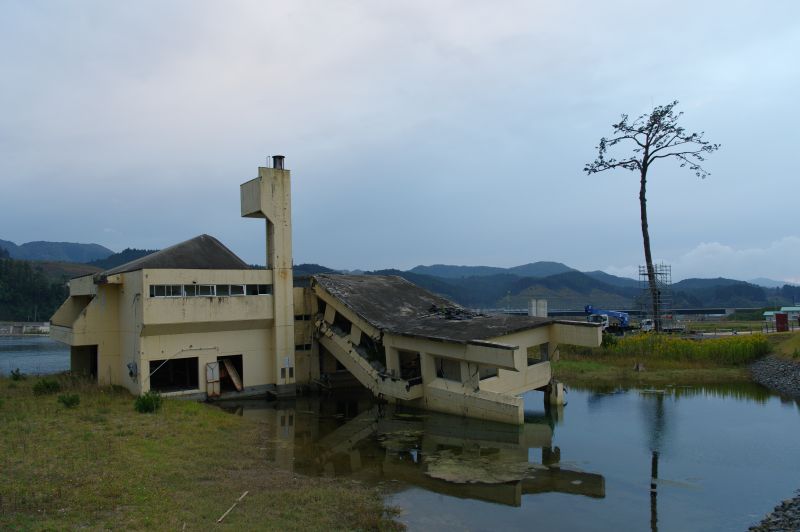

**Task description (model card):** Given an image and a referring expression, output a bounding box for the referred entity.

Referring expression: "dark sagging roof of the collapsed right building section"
[313,274,595,343]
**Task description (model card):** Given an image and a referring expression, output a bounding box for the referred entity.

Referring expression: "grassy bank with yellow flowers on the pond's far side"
[553,333,800,385]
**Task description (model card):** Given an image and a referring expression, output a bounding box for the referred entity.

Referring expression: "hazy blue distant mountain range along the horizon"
[0,240,800,310]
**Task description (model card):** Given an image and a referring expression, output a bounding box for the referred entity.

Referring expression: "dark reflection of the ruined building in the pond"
[222,396,605,506]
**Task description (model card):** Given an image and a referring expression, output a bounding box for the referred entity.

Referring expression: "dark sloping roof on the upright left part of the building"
[97,235,251,278]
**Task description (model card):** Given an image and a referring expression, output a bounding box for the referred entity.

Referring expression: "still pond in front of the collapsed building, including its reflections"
[220,384,800,530]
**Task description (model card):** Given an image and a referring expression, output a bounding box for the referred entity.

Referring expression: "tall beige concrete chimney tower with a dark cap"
[240,155,295,395]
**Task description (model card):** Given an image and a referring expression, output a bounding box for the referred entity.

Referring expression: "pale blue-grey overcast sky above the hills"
[0,0,800,282]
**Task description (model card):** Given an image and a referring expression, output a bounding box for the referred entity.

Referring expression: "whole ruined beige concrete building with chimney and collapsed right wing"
[51,156,601,424]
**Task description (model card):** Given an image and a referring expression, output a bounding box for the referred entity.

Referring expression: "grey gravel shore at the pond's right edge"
[750,355,800,532]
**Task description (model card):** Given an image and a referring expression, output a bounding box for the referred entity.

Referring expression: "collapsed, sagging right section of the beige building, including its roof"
[310,275,601,424]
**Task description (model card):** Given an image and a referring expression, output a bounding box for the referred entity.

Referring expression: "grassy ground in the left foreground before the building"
[0,376,398,530]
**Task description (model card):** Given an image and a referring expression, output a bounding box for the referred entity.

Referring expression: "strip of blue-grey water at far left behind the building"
[0,336,69,375]
